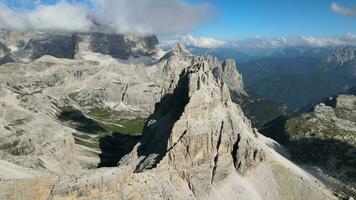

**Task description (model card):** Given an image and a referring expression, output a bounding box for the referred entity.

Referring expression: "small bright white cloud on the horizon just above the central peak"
[161,35,225,48]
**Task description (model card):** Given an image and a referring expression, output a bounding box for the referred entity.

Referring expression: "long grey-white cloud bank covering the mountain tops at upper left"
[0,0,216,35]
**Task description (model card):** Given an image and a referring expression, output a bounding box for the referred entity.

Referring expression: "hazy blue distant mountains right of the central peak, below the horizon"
[240,47,356,109]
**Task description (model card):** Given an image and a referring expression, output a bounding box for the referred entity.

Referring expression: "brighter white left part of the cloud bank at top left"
[0,1,93,32]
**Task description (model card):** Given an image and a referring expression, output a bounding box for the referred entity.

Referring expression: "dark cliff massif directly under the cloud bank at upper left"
[0,30,159,62]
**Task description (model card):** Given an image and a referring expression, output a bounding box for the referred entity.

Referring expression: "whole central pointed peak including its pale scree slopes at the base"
[50,62,334,199]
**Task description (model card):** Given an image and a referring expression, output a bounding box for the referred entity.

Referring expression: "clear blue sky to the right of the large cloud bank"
[191,0,356,40]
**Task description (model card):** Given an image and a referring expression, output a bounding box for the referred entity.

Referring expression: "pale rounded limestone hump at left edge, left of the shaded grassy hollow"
[0,89,79,174]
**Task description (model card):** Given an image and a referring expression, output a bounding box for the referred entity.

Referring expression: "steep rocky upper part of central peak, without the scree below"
[124,62,265,197]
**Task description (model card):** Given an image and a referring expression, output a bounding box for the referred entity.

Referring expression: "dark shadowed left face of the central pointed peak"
[135,67,190,172]
